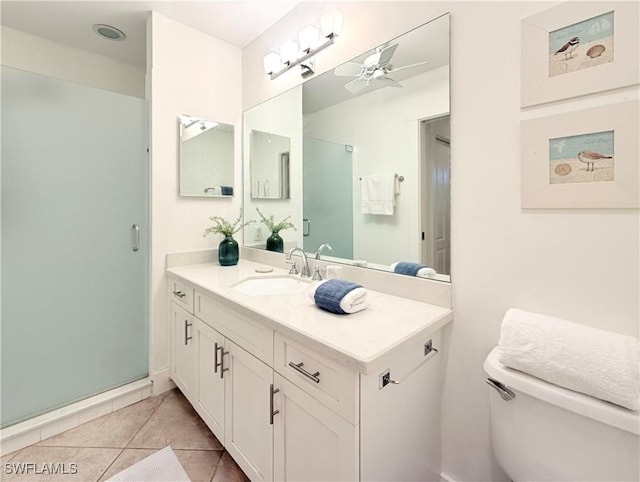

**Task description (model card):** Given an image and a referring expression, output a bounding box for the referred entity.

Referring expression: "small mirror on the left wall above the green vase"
[178,115,234,197]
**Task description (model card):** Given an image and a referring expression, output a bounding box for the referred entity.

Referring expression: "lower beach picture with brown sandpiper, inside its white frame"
[549,131,614,184]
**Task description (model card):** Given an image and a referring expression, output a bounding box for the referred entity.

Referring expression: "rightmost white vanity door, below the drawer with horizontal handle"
[273,373,358,481]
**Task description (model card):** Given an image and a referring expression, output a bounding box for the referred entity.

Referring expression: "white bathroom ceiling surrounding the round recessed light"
[0,0,299,68]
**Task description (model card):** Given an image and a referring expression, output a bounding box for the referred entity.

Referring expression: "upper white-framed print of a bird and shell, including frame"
[521,2,640,107]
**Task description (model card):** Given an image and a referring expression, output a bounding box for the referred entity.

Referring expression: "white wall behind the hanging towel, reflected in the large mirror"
[304,67,449,265]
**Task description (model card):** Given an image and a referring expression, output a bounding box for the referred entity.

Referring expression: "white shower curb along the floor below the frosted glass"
[0,378,152,455]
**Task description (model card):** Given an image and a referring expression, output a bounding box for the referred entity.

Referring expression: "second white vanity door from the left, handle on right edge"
[195,318,225,444]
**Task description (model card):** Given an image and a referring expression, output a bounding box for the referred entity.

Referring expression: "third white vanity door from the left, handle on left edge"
[224,339,273,482]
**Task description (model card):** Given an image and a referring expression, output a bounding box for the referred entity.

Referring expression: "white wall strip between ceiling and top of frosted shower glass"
[0,27,145,97]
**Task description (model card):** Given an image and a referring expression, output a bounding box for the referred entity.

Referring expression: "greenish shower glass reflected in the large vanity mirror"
[302,137,353,259]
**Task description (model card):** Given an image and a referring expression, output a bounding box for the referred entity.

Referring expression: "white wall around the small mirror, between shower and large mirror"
[147,13,242,384]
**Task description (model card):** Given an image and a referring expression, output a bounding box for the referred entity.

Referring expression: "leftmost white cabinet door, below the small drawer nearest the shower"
[169,302,197,403]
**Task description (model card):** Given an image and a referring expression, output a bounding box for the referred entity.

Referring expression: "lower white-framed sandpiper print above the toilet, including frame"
[521,100,640,209]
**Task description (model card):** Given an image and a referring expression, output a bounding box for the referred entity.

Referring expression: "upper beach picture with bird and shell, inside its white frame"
[549,12,614,77]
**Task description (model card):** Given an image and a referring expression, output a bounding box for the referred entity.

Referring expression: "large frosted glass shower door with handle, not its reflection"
[1,67,149,427]
